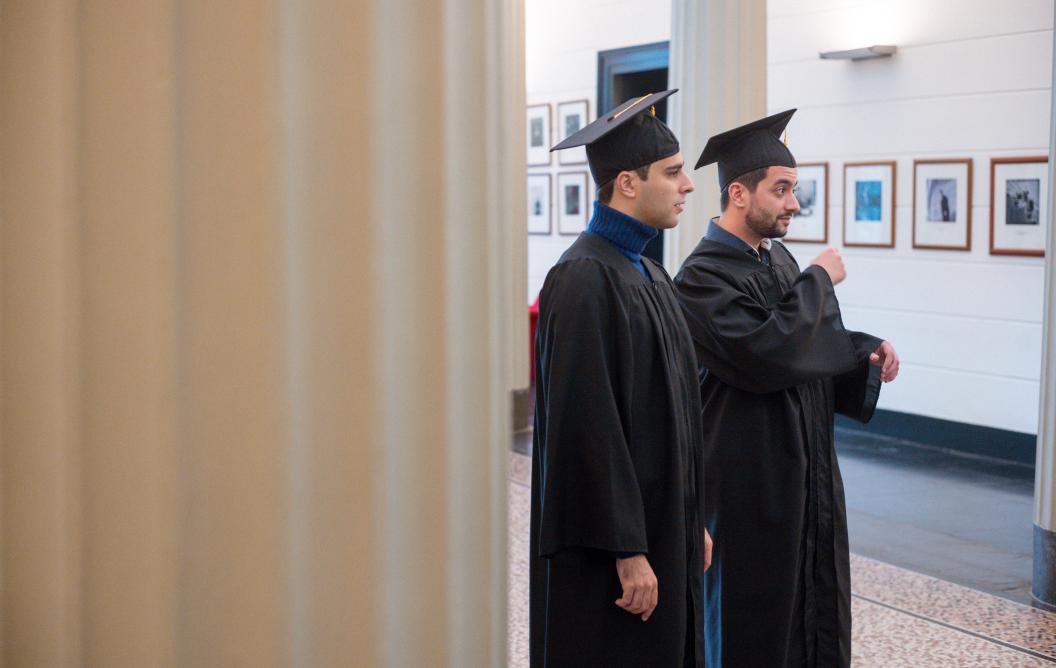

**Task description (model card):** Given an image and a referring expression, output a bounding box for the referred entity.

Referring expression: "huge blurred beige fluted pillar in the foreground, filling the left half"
[0,0,527,668]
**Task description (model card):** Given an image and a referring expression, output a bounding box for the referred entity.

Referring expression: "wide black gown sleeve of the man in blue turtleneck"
[535,260,648,557]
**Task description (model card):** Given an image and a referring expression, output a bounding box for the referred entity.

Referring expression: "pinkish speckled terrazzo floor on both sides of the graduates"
[509,443,1056,668]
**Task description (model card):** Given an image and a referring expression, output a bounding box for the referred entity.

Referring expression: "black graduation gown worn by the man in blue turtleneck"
[529,233,704,668]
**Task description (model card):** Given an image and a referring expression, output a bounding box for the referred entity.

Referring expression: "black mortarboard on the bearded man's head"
[694,109,795,189]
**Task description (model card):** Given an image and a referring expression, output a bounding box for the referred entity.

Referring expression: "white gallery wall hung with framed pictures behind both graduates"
[526,0,1053,434]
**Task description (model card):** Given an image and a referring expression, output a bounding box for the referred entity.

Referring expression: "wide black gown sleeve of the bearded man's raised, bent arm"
[675,263,868,394]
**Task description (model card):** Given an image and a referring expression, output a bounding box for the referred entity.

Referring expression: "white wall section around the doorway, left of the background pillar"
[525,0,671,302]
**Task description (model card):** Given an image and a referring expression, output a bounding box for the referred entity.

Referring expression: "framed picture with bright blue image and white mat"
[844,160,894,248]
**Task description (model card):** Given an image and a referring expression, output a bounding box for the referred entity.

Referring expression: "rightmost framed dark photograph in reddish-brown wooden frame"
[991,155,1049,255]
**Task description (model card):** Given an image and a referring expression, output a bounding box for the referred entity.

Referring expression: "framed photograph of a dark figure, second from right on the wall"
[913,158,972,250]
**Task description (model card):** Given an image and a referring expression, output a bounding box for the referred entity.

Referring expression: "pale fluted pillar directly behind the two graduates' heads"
[664,0,767,271]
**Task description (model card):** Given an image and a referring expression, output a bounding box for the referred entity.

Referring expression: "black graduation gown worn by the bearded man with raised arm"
[675,238,881,668]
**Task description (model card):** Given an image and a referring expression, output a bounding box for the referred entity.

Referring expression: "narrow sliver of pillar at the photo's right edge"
[1031,22,1056,611]
